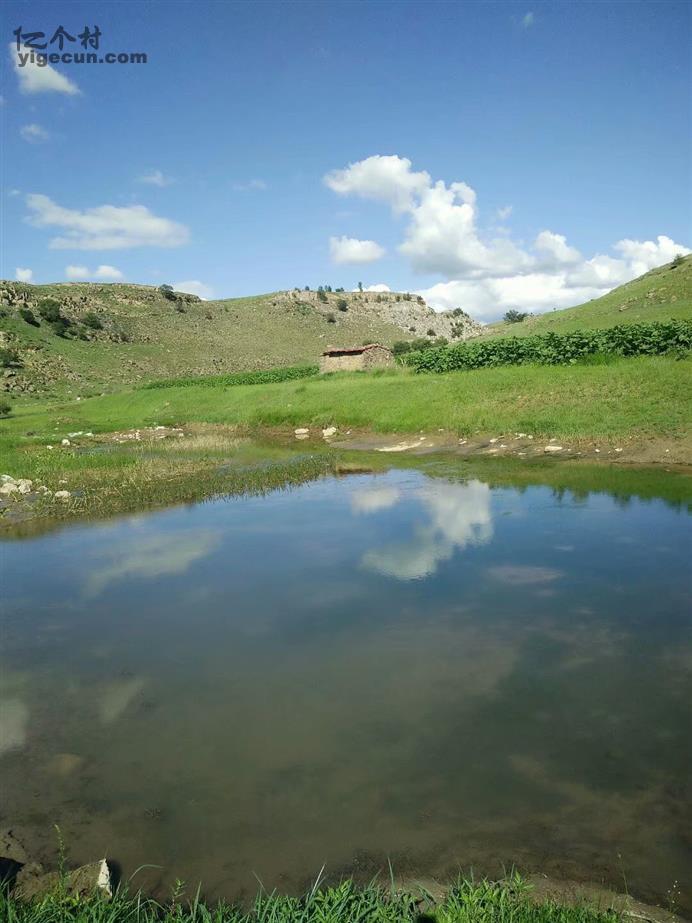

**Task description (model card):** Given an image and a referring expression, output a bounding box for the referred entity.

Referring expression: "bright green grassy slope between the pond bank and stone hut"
[0,357,692,445]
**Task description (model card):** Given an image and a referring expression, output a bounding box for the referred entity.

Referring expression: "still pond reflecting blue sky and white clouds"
[0,459,692,909]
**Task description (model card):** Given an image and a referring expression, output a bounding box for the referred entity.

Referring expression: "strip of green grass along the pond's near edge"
[0,875,623,923]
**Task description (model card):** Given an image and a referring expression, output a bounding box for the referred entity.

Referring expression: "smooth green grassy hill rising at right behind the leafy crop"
[482,256,692,336]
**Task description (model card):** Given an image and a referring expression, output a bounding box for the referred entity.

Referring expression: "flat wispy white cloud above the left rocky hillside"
[26,194,189,250]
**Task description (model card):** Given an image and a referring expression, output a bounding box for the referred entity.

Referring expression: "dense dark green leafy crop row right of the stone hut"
[406,320,692,372]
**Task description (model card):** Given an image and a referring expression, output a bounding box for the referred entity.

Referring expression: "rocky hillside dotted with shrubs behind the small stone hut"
[0,282,480,396]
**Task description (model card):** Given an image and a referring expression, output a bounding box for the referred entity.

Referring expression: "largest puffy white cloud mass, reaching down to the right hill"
[324,155,691,320]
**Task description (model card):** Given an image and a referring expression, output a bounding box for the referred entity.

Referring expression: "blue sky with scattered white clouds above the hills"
[0,0,692,319]
